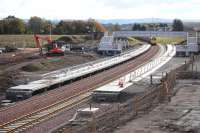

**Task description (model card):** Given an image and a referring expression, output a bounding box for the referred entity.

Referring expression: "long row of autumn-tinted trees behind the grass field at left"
[0,16,103,34]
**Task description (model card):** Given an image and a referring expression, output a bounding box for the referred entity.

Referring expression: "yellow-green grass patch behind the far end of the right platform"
[156,37,186,44]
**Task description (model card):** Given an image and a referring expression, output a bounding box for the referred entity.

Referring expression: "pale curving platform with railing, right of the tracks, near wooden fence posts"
[92,45,176,102]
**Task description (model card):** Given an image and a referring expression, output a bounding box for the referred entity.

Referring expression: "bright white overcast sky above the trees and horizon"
[0,0,200,19]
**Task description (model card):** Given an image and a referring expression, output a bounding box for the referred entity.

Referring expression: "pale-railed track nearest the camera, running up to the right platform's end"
[0,92,91,133]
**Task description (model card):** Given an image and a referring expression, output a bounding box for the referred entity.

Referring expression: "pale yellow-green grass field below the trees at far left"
[0,35,63,48]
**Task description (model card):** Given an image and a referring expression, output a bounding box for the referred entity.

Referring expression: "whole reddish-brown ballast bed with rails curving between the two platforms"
[0,46,159,133]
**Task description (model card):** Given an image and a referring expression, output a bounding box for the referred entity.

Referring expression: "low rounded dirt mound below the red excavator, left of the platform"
[21,63,45,72]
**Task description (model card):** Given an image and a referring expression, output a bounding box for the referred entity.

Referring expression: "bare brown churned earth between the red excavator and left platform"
[0,37,101,91]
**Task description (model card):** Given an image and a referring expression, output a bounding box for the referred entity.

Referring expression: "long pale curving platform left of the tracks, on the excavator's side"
[6,44,150,101]
